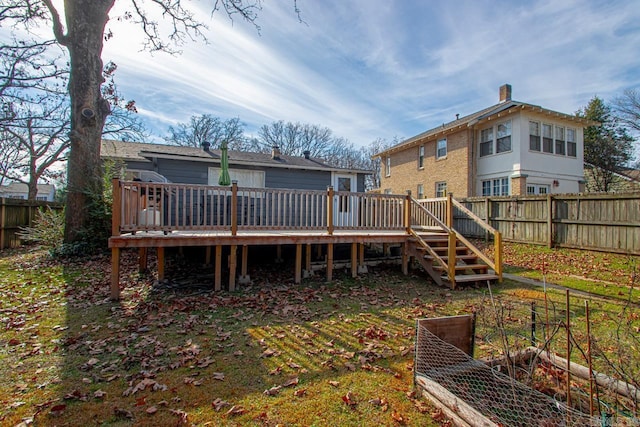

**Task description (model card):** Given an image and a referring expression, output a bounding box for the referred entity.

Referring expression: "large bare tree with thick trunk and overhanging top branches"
[0,0,297,242]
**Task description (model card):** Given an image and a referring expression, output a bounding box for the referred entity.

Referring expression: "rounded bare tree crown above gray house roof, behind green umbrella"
[165,114,246,150]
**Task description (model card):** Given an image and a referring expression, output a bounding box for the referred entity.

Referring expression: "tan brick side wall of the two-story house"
[381,129,473,198]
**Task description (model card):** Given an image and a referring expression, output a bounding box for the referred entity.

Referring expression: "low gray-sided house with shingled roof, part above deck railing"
[100,140,371,192]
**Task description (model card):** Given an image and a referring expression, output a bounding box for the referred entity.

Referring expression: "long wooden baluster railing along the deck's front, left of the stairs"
[112,179,406,235]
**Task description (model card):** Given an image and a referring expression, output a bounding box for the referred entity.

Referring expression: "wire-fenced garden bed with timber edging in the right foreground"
[415,294,640,427]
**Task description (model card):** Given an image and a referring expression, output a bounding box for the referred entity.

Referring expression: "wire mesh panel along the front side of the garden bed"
[415,324,600,427]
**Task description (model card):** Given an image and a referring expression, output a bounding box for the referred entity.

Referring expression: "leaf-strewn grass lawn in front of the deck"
[0,248,640,426]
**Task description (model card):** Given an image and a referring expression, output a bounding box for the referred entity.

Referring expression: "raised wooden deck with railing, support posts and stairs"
[109,180,501,299]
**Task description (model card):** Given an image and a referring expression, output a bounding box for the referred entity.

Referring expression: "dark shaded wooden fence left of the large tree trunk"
[0,198,63,249]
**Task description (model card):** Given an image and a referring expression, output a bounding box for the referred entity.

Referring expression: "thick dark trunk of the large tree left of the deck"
[64,0,115,242]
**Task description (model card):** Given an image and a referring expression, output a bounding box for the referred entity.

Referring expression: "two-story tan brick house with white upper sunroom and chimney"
[375,84,595,199]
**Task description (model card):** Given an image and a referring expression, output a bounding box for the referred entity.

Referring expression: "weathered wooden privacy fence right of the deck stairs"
[453,193,640,255]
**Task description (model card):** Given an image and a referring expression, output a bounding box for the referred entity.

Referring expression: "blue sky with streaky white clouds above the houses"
[103,0,640,147]
